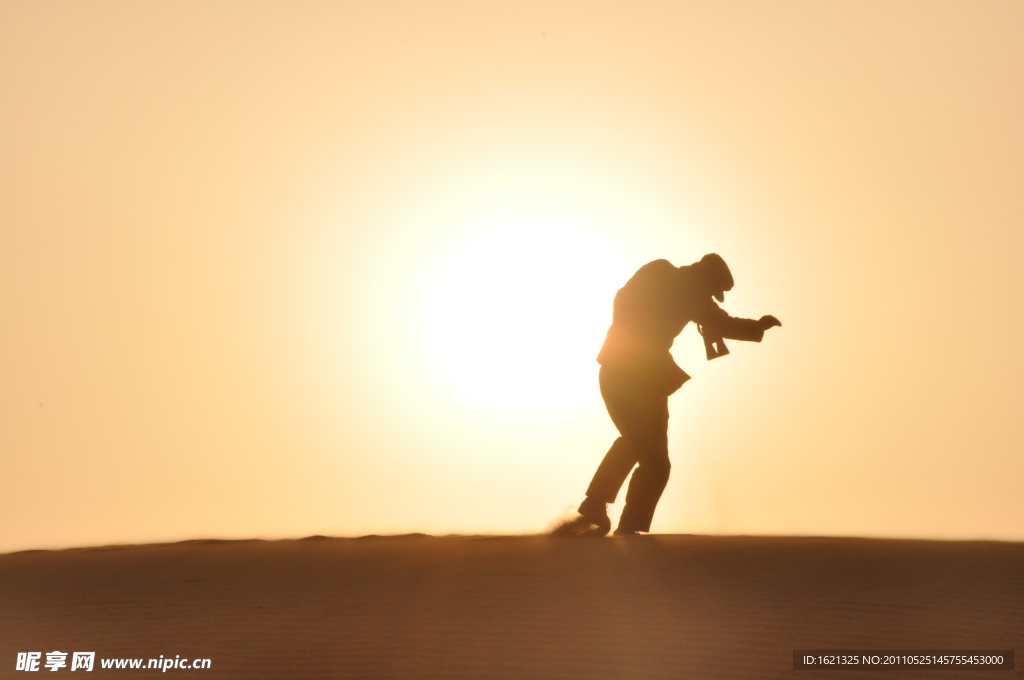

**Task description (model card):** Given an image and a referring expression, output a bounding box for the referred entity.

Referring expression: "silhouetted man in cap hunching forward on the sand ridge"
[556,253,781,536]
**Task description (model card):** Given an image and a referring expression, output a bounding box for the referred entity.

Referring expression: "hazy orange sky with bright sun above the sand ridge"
[0,0,1024,551]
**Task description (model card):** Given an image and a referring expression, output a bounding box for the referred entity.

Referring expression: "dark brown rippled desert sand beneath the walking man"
[0,536,1024,680]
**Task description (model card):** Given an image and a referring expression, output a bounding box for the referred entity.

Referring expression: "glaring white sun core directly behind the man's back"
[425,214,624,410]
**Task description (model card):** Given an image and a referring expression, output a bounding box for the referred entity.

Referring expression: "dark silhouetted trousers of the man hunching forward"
[587,366,672,532]
